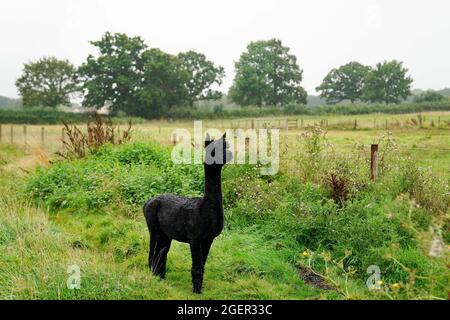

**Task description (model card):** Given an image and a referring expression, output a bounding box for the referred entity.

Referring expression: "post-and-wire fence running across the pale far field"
[0,115,450,148]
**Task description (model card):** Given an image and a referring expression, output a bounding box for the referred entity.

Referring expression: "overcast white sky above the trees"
[0,0,450,97]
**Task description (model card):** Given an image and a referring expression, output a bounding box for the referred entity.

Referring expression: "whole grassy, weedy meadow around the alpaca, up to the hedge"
[0,111,450,299]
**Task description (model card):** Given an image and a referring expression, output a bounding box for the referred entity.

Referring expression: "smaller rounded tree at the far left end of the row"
[16,57,78,108]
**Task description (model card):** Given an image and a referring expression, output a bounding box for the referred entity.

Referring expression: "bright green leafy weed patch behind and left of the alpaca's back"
[26,143,202,211]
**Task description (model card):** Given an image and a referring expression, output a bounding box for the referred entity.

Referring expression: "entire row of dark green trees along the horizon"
[16,32,436,117]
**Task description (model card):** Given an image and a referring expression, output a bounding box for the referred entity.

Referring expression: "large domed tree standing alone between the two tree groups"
[229,39,306,106]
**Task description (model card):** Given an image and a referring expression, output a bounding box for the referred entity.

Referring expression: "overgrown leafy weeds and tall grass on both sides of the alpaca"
[16,129,449,299]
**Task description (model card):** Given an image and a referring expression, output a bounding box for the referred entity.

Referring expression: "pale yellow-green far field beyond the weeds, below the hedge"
[0,112,450,177]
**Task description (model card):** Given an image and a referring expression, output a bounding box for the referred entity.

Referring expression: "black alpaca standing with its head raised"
[144,135,232,293]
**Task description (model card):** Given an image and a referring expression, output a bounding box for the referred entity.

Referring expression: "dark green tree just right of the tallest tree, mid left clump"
[137,49,191,117]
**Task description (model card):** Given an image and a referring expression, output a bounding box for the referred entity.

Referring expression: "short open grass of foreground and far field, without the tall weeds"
[0,112,450,299]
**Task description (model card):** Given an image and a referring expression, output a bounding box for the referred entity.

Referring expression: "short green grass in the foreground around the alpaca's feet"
[0,147,323,299]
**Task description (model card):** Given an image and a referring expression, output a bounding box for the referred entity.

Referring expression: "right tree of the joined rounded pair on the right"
[363,60,413,104]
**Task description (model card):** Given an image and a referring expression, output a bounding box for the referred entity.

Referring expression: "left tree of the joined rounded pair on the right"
[316,62,370,103]
